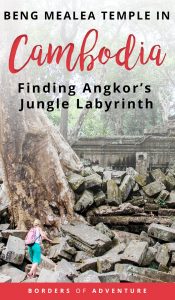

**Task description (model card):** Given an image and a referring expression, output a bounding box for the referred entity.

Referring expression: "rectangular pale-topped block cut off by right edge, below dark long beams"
[148,223,175,242]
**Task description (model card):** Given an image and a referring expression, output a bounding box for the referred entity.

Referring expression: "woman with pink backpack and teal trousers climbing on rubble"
[25,219,52,278]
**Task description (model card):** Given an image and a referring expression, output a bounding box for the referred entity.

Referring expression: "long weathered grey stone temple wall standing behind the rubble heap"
[73,135,175,170]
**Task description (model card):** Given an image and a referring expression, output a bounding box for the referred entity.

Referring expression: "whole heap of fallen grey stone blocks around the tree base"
[0,165,175,283]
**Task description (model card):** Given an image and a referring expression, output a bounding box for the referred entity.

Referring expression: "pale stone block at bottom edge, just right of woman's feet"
[37,268,71,282]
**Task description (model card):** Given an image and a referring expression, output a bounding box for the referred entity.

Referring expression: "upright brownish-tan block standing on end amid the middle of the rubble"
[107,179,122,205]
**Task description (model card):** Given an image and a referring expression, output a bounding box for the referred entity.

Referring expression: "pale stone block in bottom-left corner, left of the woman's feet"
[0,263,26,282]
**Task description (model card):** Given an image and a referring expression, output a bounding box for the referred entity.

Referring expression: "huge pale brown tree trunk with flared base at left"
[0,72,81,234]
